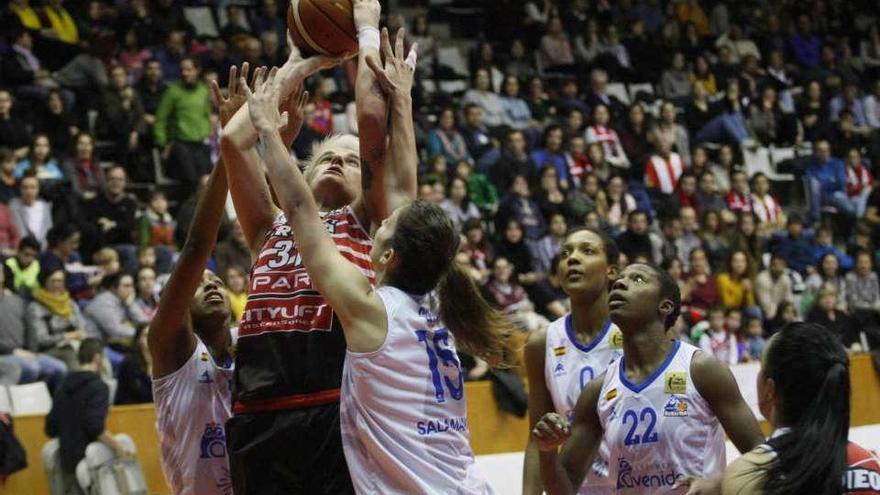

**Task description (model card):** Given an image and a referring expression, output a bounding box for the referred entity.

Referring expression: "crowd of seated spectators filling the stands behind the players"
[0,0,880,403]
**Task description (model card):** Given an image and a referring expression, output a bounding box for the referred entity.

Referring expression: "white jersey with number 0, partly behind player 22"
[544,314,623,494]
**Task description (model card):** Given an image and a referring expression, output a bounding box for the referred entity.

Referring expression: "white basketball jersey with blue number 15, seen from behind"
[340,286,492,495]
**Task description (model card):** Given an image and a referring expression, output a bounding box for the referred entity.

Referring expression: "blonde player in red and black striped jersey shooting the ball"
[221,0,417,494]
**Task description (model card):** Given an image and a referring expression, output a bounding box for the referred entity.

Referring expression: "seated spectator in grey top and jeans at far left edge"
[0,270,67,390]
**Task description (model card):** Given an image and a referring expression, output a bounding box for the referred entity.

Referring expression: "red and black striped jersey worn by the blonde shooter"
[233,206,375,413]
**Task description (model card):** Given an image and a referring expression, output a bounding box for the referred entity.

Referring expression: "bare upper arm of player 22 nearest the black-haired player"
[691,352,764,453]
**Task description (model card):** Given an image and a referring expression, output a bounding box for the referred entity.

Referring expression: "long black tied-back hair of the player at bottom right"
[761,323,850,495]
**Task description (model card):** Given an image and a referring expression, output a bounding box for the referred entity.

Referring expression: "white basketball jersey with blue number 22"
[598,340,727,494]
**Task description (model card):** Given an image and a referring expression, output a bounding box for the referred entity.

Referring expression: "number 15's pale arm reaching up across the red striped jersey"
[245,71,388,352]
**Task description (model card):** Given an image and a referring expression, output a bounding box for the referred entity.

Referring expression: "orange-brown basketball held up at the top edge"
[287,0,358,56]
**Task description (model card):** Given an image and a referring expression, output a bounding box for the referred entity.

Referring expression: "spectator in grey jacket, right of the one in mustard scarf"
[84,273,149,348]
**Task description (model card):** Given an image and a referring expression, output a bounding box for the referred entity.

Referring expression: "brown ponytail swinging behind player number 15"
[437,261,513,367]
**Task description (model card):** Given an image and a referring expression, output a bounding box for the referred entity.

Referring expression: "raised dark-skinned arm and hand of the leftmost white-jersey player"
[147,66,247,378]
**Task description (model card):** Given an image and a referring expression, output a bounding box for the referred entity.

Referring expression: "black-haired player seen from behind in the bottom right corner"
[721,323,880,495]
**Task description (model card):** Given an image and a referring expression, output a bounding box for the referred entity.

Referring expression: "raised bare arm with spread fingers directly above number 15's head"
[362,28,419,218]
